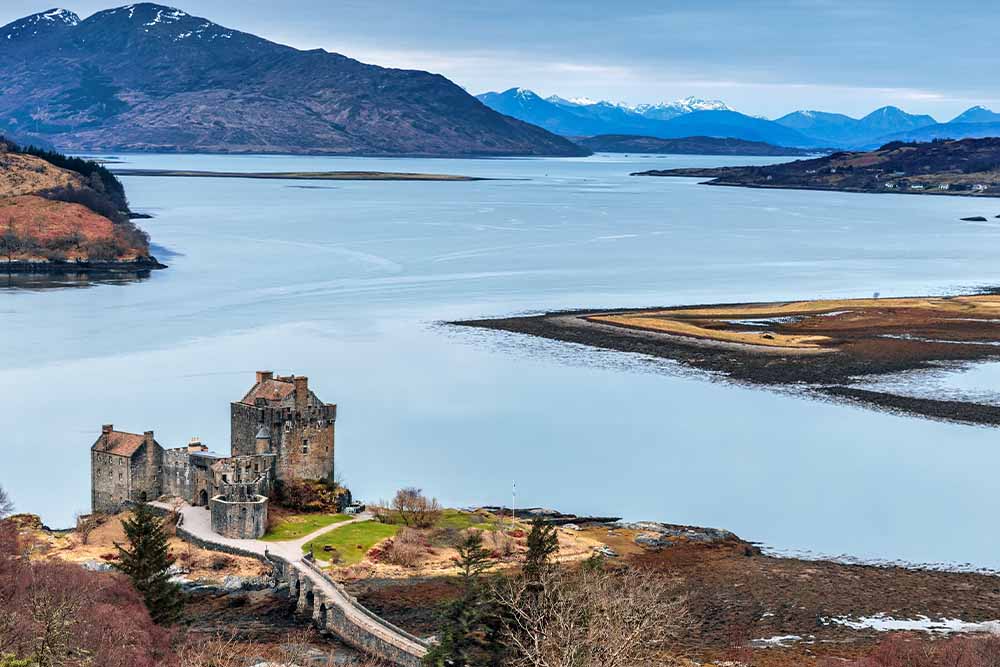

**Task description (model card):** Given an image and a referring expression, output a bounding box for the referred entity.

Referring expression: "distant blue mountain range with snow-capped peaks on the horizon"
[478,88,1000,148]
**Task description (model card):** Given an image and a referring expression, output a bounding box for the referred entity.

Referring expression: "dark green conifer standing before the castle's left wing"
[115,503,184,625]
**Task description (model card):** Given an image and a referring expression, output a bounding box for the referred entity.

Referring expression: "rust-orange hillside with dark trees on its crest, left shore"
[0,140,161,272]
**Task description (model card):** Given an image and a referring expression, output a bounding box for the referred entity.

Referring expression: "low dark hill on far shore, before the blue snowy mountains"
[577,134,814,155]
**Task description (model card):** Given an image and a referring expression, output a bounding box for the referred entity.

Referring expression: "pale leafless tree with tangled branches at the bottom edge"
[493,566,689,667]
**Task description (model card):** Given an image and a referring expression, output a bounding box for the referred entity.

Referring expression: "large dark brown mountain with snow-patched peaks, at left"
[0,3,589,156]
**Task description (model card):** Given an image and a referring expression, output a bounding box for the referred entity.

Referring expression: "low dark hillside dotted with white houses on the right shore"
[634,138,1000,196]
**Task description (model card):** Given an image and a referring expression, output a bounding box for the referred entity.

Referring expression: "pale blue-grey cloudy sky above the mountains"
[0,0,1000,120]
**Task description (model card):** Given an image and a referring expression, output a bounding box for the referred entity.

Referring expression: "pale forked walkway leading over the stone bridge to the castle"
[150,502,427,656]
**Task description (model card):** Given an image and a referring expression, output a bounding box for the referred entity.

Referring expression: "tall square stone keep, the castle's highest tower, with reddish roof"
[230,371,337,482]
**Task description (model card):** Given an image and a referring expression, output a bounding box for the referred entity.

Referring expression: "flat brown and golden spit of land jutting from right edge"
[453,293,1000,425]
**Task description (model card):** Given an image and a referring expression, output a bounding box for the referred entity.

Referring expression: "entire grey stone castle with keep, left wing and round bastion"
[90,371,337,538]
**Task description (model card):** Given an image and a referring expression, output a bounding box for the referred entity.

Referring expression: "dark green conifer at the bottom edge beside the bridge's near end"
[424,530,502,667]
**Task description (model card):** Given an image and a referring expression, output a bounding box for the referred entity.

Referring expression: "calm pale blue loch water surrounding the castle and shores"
[0,155,1000,567]
